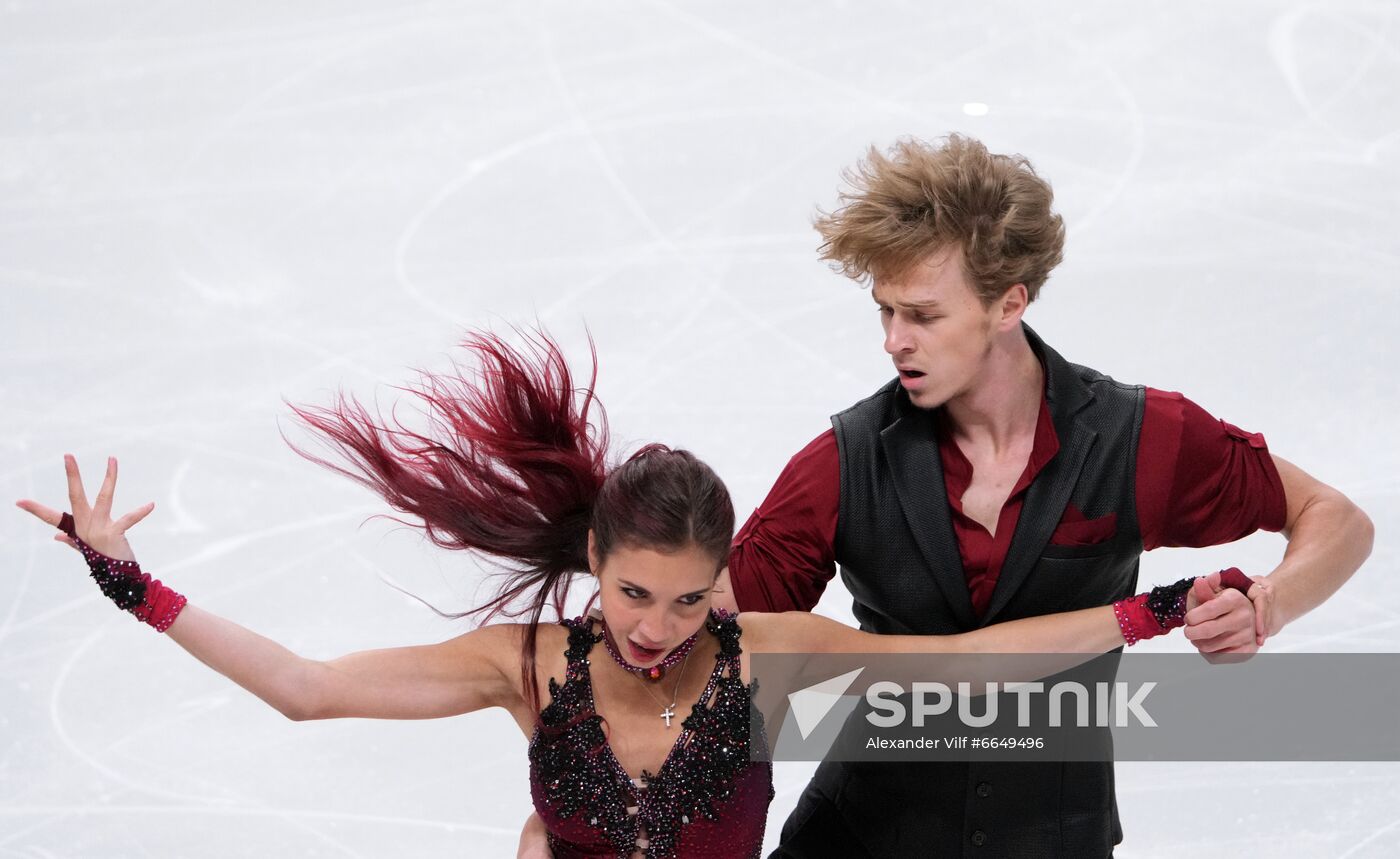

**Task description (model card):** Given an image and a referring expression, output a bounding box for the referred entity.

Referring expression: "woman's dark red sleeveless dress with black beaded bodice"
[529,611,773,859]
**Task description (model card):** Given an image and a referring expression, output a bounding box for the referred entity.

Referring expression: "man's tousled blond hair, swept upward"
[815,134,1064,305]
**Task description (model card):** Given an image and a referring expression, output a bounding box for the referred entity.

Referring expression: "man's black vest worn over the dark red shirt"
[813,327,1145,859]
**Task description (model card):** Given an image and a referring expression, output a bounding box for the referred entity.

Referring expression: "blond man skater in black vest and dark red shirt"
[717,136,1372,859]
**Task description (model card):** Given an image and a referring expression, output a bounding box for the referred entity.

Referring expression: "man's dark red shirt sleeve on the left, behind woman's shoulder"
[729,430,841,611]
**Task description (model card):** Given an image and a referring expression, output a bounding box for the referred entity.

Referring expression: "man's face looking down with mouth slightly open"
[871,248,1001,409]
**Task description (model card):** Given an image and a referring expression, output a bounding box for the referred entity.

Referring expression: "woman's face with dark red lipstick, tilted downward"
[589,536,717,667]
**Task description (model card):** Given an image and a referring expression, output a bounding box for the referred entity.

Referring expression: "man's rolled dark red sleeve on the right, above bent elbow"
[1137,388,1288,548]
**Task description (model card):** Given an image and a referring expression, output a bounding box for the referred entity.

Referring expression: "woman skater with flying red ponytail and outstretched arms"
[18,334,1250,859]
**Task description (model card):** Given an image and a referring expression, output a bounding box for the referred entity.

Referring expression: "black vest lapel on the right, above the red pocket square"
[980,323,1098,624]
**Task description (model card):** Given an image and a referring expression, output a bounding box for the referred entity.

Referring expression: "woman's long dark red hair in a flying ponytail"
[284,330,734,711]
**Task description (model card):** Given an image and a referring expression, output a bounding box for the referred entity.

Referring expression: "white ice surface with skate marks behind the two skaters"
[0,0,1400,859]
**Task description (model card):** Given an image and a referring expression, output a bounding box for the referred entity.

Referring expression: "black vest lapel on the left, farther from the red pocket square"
[881,404,977,630]
